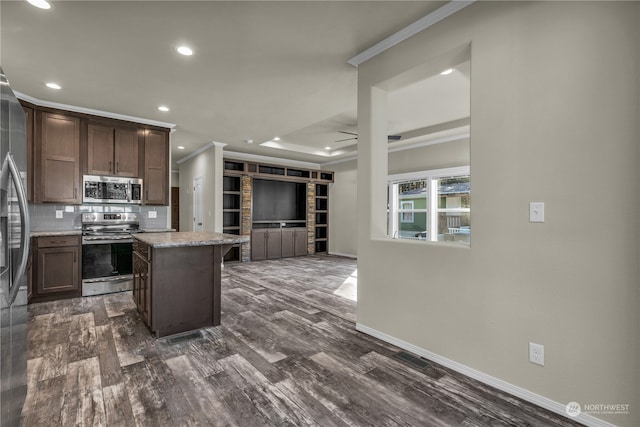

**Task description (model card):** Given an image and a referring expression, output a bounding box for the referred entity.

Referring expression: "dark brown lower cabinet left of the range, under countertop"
[29,236,81,302]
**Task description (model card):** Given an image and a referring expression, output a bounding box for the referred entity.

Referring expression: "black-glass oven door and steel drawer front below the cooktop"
[82,238,133,296]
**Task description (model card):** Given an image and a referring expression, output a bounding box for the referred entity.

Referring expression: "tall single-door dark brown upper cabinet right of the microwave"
[144,129,169,206]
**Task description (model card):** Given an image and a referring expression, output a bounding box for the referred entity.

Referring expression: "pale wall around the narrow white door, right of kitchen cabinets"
[179,145,223,233]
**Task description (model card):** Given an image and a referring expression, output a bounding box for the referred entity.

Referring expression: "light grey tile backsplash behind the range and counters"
[29,203,169,231]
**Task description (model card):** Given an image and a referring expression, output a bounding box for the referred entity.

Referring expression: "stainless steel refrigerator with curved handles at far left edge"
[0,67,29,426]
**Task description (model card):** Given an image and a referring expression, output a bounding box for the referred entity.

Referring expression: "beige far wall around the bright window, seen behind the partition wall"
[323,139,473,257]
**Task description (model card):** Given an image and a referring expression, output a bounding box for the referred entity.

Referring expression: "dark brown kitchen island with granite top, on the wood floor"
[133,231,249,337]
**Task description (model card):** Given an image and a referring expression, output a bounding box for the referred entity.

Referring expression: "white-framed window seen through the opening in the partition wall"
[388,167,471,243]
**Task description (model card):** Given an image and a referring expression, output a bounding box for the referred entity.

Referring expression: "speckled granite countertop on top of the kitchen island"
[133,231,249,248]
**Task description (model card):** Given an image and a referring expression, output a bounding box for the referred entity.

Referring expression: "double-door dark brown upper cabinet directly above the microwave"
[87,123,139,178]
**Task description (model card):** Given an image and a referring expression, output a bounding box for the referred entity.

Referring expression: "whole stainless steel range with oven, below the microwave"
[82,213,140,296]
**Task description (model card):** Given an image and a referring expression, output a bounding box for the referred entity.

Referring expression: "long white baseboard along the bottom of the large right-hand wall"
[356,323,615,427]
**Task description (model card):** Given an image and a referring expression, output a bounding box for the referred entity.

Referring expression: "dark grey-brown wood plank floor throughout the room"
[22,256,577,427]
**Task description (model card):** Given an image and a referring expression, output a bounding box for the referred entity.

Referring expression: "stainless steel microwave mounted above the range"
[82,175,142,204]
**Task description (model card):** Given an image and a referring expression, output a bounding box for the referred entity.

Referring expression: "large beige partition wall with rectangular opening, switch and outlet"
[357,2,640,426]
